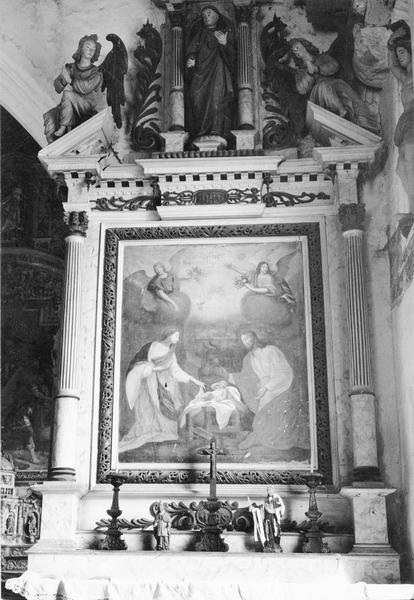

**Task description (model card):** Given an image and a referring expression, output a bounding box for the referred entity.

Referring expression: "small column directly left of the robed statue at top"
[168,10,184,131]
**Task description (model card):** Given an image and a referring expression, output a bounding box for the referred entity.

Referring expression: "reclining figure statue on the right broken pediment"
[287,38,377,131]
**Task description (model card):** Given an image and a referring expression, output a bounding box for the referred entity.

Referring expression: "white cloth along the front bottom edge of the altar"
[6,571,414,600]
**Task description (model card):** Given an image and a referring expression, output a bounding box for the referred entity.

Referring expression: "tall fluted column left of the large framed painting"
[49,212,88,481]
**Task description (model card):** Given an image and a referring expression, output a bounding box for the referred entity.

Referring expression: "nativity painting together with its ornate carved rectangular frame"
[97,223,332,484]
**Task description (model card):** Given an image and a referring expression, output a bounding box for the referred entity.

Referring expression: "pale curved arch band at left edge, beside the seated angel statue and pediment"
[0,52,56,147]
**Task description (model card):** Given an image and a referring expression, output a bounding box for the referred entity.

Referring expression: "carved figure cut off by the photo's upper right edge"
[388,21,414,213]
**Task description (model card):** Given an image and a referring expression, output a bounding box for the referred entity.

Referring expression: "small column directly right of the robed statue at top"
[236,6,254,129]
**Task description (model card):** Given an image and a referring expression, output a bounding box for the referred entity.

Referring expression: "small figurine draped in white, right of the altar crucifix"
[249,488,285,552]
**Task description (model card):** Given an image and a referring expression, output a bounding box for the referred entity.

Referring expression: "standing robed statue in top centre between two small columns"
[186,5,235,139]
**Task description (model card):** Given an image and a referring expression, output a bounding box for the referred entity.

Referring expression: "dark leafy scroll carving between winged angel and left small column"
[132,21,162,151]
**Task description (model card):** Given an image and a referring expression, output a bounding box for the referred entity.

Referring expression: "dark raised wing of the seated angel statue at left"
[99,33,128,129]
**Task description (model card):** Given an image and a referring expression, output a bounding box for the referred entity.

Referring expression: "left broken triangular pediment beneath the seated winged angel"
[38,109,116,171]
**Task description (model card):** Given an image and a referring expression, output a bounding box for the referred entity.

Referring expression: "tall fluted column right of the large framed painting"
[339,203,380,481]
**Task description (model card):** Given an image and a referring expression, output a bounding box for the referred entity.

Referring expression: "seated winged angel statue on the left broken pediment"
[44,33,128,144]
